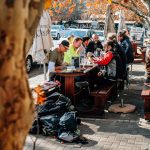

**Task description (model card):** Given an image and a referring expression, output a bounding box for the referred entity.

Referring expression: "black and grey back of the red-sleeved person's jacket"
[106,50,124,80]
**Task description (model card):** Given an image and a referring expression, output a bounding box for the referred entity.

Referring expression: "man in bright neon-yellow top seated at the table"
[64,37,82,65]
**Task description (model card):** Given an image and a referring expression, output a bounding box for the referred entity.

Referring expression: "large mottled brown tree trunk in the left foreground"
[0,0,44,150]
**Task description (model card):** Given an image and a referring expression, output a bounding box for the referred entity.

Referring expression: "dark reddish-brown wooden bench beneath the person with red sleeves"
[90,83,117,114]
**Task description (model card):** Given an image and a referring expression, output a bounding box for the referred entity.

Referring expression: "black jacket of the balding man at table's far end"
[86,41,103,53]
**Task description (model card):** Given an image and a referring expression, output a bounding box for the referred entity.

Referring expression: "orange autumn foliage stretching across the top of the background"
[50,0,150,25]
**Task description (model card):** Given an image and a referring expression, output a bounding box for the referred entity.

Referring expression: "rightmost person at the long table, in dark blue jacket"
[118,31,134,65]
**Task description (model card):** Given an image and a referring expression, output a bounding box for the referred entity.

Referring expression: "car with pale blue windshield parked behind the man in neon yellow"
[62,29,95,39]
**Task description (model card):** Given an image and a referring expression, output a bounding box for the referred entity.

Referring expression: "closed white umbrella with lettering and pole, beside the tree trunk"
[32,10,54,80]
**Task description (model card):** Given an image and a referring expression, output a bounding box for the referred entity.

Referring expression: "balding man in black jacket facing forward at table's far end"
[86,34,103,53]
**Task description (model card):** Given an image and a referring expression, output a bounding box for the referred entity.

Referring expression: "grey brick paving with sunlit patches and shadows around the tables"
[24,64,150,150]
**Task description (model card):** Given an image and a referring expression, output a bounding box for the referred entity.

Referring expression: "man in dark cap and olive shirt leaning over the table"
[48,40,69,77]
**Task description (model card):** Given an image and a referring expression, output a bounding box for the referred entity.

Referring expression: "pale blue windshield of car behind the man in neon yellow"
[64,30,86,38]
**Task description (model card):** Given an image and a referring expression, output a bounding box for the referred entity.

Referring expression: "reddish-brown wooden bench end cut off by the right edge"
[141,81,150,120]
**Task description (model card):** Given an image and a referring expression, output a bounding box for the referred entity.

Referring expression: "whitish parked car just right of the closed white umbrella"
[51,25,65,40]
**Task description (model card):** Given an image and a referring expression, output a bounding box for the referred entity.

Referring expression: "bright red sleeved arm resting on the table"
[93,52,113,66]
